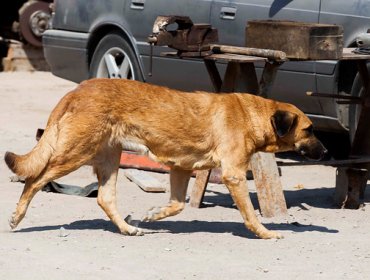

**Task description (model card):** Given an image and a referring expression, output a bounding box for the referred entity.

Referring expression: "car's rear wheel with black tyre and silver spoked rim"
[90,33,143,81]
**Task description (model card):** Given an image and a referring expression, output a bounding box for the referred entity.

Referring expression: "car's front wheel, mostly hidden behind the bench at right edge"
[348,64,370,143]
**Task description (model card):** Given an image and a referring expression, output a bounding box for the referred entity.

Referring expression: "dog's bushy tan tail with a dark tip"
[4,125,58,178]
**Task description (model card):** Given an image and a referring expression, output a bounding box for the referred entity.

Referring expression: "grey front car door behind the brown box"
[211,0,322,114]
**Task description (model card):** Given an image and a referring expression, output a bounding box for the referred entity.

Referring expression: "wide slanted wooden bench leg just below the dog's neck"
[250,153,288,217]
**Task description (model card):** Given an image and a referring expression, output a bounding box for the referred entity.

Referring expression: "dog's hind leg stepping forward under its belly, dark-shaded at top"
[94,147,143,235]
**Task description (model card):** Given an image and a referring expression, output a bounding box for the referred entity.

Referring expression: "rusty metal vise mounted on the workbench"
[148,16,218,57]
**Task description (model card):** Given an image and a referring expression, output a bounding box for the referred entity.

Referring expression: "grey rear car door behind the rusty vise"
[124,0,212,90]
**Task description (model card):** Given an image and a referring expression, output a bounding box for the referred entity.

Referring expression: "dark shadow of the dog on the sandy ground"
[14,219,338,239]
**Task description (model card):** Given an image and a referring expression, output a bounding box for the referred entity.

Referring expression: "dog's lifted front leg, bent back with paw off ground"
[142,169,192,221]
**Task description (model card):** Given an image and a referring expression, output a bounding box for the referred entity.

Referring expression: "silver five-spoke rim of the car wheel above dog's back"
[96,47,135,80]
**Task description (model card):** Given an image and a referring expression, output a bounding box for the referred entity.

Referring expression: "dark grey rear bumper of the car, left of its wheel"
[42,29,89,83]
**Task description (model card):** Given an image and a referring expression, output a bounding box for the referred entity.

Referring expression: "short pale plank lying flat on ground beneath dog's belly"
[124,169,166,192]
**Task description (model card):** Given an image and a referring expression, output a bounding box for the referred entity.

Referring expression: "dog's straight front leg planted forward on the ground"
[222,169,283,239]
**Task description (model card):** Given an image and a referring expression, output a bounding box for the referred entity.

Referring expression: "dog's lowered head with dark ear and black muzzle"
[271,108,327,160]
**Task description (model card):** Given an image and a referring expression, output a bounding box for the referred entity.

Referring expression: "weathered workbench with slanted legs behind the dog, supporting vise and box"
[184,48,370,214]
